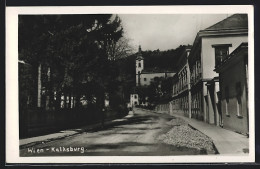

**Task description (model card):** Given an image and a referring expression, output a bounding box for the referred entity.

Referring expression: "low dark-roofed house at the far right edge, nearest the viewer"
[215,43,249,134]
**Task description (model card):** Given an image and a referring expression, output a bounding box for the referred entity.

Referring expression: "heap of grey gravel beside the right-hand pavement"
[158,125,215,154]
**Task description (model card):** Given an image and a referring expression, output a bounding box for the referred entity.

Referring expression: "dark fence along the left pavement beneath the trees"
[19,107,127,138]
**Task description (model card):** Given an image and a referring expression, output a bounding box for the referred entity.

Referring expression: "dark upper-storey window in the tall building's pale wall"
[212,44,232,67]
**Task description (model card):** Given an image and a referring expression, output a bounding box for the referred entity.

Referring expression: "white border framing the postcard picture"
[6,5,255,163]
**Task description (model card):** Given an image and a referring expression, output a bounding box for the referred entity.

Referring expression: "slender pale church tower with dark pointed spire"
[135,45,144,86]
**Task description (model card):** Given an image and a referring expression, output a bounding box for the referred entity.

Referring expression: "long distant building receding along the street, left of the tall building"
[169,45,191,117]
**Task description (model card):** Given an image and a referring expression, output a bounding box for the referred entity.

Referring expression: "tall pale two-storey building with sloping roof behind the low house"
[188,14,248,125]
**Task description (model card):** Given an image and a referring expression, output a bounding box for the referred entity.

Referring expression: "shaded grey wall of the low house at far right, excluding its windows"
[220,60,248,134]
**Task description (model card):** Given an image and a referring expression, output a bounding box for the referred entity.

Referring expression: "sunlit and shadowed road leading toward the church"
[20,109,198,156]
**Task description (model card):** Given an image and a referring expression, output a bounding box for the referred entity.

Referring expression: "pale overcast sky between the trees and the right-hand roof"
[119,14,230,50]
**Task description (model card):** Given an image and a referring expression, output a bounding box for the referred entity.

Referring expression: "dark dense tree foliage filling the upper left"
[18,14,129,115]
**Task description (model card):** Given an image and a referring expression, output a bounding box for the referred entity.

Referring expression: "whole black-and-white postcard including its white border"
[6,5,255,163]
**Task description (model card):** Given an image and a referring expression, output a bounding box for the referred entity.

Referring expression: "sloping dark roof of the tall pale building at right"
[205,14,248,30]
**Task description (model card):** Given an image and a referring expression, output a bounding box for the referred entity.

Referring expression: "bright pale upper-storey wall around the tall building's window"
[201,36,248,78]
